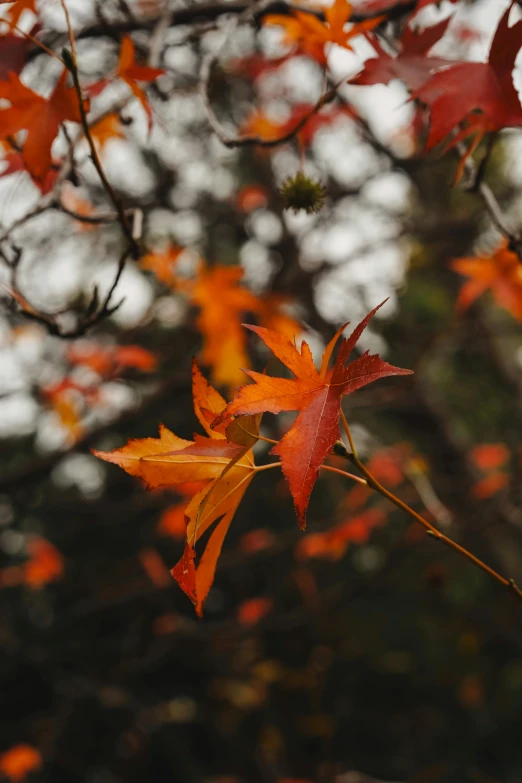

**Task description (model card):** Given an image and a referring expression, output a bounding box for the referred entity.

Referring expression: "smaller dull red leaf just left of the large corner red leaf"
[350,17,451,90]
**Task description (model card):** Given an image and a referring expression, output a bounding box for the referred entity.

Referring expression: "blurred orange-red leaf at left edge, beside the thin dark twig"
[0,69,88,184]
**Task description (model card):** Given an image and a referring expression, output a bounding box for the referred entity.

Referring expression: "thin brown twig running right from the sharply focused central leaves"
[336,411,522,600]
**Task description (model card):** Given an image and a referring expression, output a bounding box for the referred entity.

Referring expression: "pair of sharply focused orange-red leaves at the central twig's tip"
[94,305,411,614]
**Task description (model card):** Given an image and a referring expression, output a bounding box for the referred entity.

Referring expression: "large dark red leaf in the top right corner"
[412,0,522,150]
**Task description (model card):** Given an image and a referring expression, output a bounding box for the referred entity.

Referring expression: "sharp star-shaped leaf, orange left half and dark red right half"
[213,300,412,529]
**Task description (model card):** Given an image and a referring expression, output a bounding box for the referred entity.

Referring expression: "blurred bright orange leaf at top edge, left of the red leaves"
[263,0,385,63]
